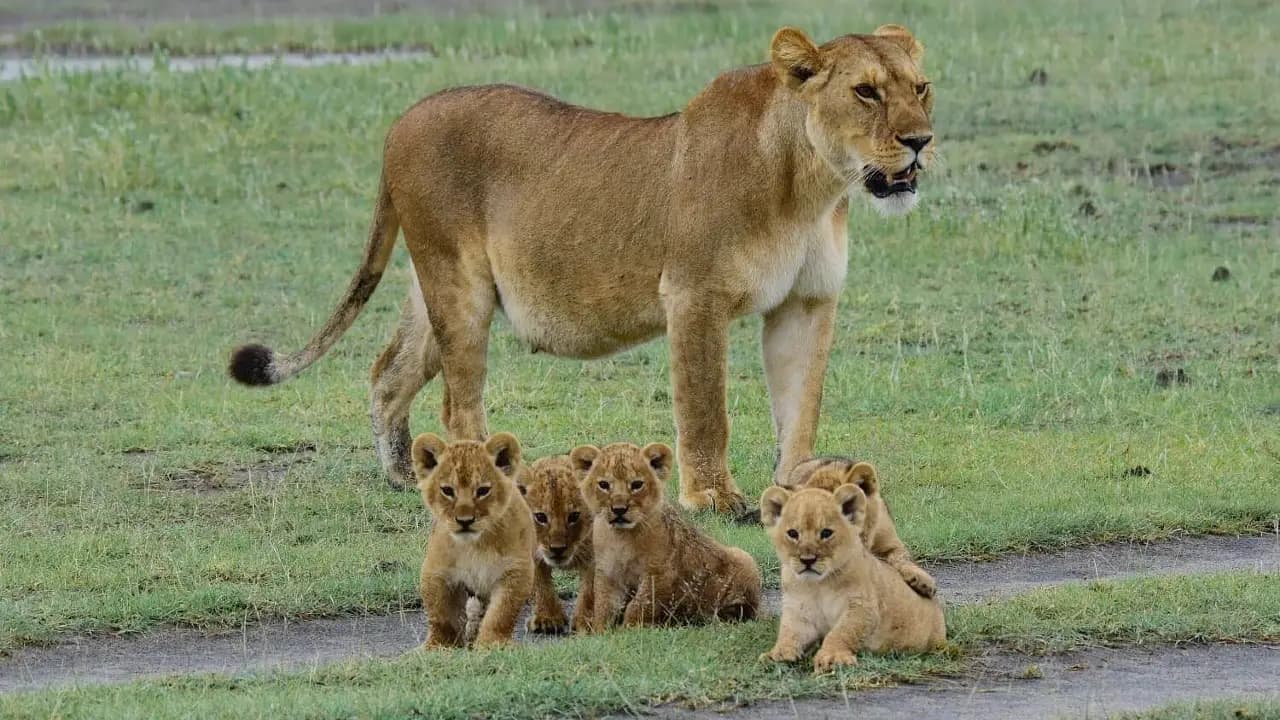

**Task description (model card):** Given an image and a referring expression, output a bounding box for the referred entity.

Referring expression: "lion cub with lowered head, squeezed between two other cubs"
[517,455,595,633]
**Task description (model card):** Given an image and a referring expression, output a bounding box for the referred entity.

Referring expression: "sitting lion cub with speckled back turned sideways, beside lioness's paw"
[571,442,760,630]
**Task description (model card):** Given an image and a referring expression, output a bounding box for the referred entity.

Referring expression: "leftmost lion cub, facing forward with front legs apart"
[412,433,534,647]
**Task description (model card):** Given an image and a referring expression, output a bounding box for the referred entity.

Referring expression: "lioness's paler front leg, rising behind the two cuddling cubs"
[762,297,836,483]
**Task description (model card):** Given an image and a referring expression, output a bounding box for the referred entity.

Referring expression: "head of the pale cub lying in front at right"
[760,484,867,582]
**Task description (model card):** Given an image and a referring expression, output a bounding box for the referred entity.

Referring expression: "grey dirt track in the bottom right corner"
[655,644,1280,720]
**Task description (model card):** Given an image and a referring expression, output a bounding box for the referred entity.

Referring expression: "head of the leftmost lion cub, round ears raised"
[413,433,524,542]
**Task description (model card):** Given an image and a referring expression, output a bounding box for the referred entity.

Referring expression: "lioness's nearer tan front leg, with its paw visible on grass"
[667,292,746,514]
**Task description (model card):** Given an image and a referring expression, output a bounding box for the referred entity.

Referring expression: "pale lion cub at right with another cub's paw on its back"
[760,484,947,674]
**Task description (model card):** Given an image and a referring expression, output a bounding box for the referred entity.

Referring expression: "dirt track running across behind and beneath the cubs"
[0,536,1280,692]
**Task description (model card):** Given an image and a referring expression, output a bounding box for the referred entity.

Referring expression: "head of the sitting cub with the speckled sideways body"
[570,442,672,529]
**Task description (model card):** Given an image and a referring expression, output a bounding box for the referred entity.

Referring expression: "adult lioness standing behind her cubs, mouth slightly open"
[230,26,937,514]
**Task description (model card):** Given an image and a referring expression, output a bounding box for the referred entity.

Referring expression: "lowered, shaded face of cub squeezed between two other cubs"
[516,455,591,568]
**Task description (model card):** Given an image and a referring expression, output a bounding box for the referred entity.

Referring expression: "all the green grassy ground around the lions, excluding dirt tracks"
[0,0,1280,717]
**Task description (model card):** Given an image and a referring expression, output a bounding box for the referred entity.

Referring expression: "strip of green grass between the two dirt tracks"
[0,573,1280,719]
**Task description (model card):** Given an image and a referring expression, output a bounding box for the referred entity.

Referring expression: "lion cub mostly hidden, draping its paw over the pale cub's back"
[783,457,938,597]
